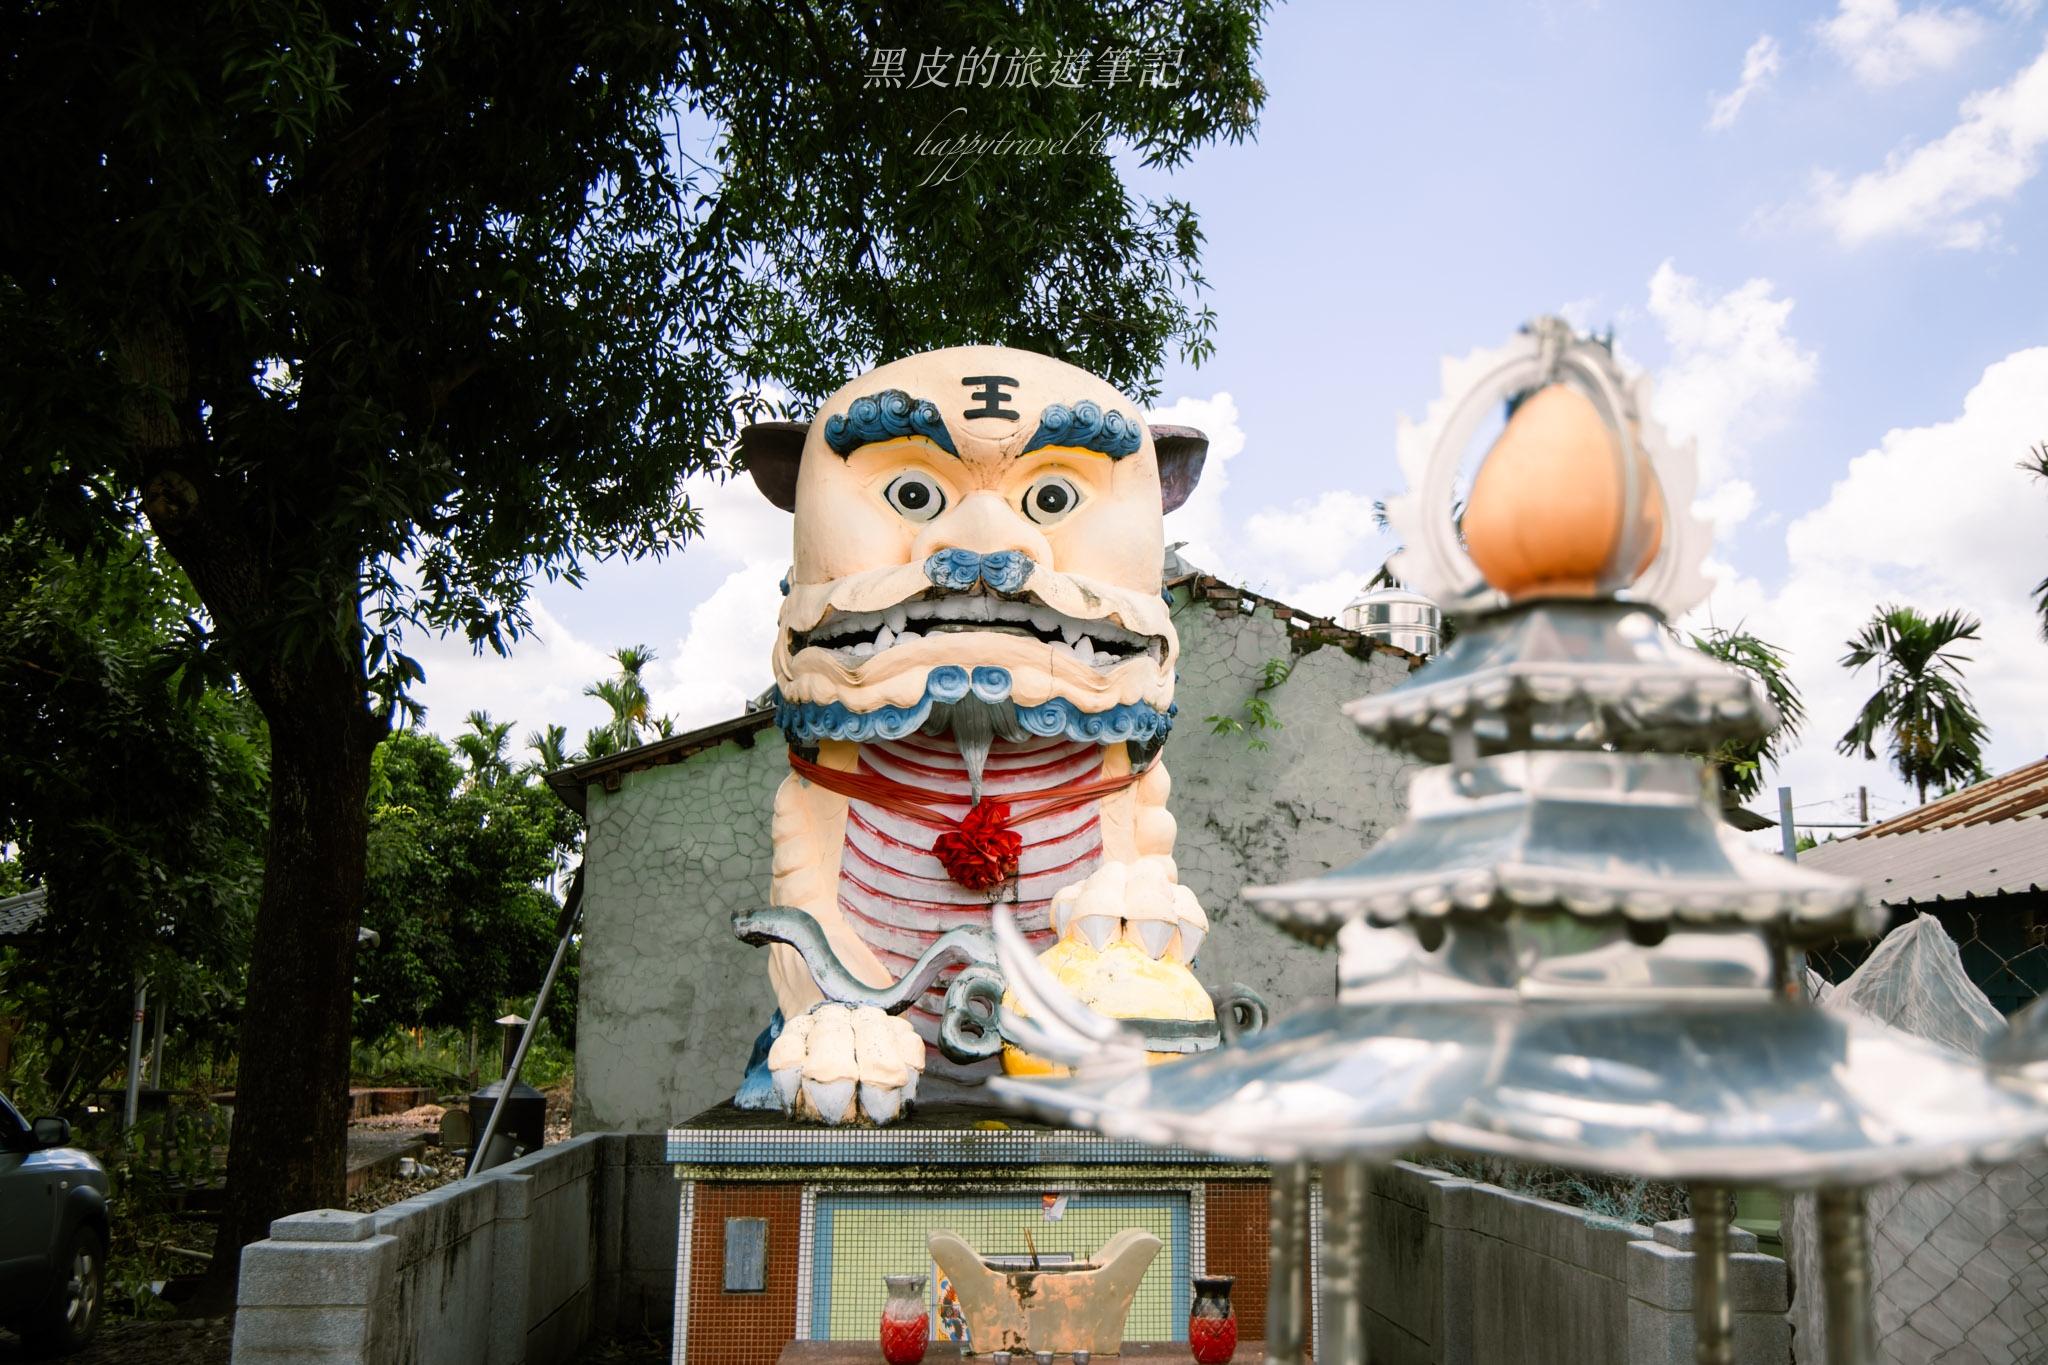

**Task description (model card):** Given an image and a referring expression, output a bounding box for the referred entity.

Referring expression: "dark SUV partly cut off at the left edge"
[0,1095,106,1355]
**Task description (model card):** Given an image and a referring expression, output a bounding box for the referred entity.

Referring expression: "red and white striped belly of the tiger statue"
[840,735,1102,1081]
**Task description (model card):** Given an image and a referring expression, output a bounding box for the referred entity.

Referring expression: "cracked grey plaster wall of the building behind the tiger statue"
[573,581,1413,1134]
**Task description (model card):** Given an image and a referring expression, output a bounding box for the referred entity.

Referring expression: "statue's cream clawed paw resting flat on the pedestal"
[768,1001,924,1124]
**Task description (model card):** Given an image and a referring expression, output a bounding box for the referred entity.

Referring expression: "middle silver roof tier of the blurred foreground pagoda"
[1243,749,1882,941]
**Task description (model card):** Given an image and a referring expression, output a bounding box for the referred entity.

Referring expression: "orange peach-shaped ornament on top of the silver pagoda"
[1464,385,1665,602]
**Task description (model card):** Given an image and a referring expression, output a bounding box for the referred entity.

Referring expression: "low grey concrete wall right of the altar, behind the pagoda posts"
[1366,1162,1792,1365]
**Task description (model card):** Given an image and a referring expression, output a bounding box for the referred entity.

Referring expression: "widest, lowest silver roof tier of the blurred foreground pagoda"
[989,986,2048,1187]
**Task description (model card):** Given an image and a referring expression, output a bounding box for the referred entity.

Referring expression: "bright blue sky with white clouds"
[411,0,2048,834]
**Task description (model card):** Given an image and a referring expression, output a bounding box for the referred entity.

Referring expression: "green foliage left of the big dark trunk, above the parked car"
[0,524,266,1105]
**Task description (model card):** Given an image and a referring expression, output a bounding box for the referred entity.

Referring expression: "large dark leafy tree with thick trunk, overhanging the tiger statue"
[0,0,1266,1268]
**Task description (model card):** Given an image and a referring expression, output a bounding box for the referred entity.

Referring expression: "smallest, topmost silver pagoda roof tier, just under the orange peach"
[1343,600,1778,763]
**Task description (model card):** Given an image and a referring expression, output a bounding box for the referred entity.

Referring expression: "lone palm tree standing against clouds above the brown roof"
[1835,606,1989,804]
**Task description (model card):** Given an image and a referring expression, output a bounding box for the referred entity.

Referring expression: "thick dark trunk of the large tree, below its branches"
[205,651,383,1310]
